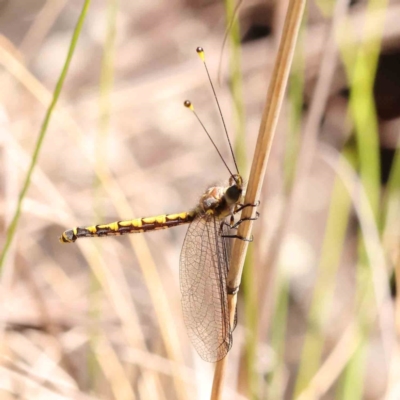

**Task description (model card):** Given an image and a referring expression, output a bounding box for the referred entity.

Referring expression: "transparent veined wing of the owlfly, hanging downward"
[180,215,232,362]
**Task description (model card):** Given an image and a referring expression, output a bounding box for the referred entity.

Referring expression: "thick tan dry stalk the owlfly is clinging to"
[211,0,306,399]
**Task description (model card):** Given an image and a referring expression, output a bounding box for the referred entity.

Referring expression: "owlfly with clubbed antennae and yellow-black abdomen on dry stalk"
[60,47,259,362]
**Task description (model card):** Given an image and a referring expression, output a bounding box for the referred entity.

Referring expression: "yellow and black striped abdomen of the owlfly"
[60,211,196,243]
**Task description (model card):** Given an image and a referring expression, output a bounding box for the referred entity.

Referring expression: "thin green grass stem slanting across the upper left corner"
[0,0,91,272]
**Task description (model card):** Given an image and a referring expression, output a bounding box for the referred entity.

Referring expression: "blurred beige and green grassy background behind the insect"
[0,0,400,400]
